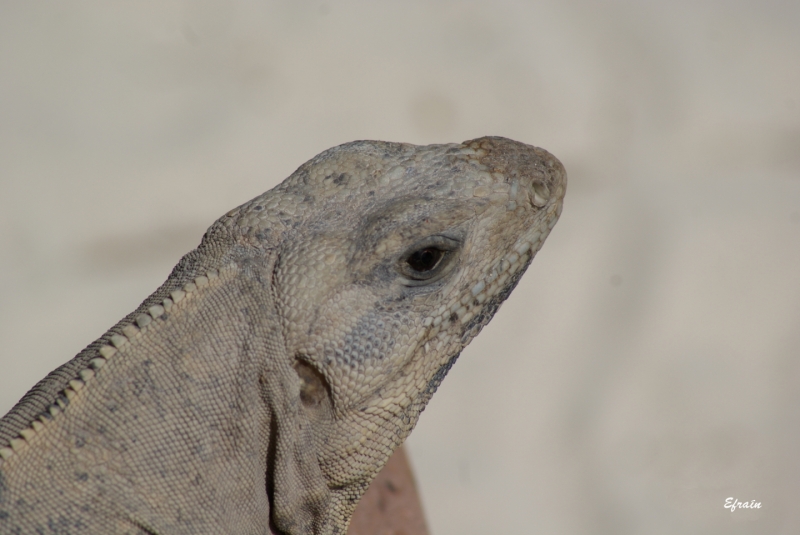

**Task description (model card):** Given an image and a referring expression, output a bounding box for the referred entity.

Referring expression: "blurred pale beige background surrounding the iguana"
[0,0,800,535]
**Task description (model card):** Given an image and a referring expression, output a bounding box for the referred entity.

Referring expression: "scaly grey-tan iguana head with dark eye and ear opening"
[222,137,567,528]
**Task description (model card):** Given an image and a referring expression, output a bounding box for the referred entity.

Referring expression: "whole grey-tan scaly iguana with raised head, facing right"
[0,137,567,535]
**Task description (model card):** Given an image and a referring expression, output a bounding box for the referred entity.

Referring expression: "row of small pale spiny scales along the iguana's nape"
[0,271,219,464]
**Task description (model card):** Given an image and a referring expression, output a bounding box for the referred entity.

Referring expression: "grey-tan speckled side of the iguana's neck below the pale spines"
[4,253,296,533]
